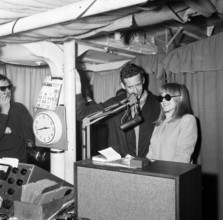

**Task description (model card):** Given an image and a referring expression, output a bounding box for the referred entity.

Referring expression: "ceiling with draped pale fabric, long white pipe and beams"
[0,0,223,65]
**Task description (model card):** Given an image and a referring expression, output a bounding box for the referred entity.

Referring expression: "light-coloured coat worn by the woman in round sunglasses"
[146,114,197,163]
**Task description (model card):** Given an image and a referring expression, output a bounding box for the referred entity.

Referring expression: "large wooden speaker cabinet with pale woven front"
[74,159,201,220]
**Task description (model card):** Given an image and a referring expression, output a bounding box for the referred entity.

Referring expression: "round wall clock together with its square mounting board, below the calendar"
[33,106,67,150]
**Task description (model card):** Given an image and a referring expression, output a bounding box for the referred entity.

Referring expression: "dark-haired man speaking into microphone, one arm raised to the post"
[76,63,160,157]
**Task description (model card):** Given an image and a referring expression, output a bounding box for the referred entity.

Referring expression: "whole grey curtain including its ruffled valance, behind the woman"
[126,33,223,220]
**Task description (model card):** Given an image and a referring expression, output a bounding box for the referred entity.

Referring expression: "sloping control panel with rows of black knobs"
[0,163,72,216]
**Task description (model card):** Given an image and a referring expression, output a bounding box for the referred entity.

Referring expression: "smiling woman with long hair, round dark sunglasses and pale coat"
[146,83,197,163]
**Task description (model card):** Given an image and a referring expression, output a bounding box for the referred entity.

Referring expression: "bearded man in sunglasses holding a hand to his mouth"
[0,74,34,163]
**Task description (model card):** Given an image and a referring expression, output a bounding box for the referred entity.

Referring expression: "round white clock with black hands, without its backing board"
[33,111,62,144]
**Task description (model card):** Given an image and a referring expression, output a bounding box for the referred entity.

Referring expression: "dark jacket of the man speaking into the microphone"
[77,92,160,157]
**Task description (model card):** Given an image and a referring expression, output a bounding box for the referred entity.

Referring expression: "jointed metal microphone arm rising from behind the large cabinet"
[82,99,131,160]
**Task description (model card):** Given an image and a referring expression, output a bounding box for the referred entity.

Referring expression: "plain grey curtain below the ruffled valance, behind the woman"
[169,70,223,220]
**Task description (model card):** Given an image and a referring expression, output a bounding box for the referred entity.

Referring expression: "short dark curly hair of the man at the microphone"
[120,63,145,83]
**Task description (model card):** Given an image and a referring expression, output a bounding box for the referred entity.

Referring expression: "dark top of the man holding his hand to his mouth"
[0,102,34,163]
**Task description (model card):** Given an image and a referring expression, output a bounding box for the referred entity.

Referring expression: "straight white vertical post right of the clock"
[64,40,76,184]
